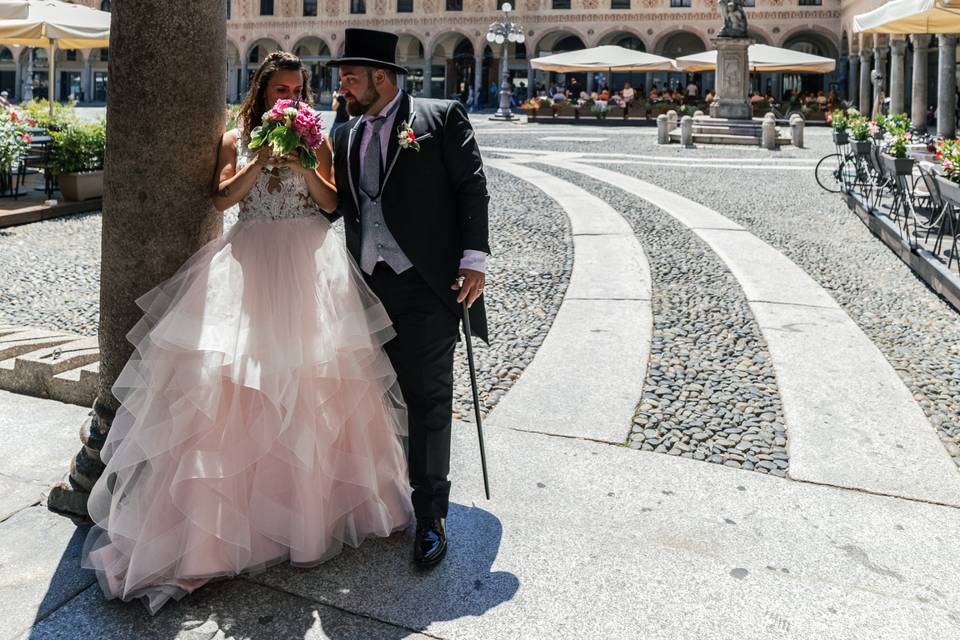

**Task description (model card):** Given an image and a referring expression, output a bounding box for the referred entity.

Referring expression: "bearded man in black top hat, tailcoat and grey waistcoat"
[329,29,490,566]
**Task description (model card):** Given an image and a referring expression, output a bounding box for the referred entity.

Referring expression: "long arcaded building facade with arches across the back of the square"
[20,0,956,122]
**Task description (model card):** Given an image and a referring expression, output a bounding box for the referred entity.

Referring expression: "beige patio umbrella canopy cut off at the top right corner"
[853,0,960,33]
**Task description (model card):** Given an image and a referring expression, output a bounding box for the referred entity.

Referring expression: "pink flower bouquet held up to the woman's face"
[250,100,324,169]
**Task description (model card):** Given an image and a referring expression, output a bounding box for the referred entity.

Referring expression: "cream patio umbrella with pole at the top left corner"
[0,0,110,114]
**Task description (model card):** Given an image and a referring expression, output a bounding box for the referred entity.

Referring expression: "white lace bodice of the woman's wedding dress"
[237,130,320,221]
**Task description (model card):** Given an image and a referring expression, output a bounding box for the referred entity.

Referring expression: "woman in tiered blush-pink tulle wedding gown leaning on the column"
[83,52,413,613]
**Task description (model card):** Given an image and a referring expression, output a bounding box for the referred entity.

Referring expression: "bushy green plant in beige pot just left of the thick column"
[50,122,106,201]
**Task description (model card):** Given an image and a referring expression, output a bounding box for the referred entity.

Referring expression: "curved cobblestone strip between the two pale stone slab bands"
[537,165,788,477]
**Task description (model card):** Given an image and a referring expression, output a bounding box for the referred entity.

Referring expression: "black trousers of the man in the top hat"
[367,262,460,518]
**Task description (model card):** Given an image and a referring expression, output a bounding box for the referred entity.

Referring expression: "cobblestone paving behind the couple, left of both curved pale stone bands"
[0,170,573,421]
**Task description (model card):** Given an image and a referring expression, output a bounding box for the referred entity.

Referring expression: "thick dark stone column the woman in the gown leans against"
[48,0,227,521]
